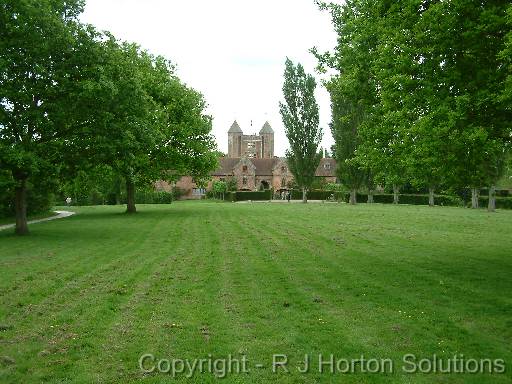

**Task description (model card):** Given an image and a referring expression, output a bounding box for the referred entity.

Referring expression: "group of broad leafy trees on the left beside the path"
[0,0,216,234]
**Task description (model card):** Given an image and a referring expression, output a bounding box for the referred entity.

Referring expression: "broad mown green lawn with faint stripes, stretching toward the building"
[0,202,512,384]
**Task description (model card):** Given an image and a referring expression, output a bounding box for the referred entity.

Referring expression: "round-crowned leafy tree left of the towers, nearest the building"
[85,41,216,213]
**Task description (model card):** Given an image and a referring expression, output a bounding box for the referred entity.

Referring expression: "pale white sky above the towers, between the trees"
[81,0,336,156]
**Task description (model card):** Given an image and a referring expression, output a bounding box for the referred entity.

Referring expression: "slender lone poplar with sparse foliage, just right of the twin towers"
[279,58,322,203]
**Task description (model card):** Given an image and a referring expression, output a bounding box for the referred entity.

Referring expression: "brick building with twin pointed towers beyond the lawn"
[156,121,336,199]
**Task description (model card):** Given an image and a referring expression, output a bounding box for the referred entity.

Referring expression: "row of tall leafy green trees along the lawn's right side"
[313,0,512,210]
